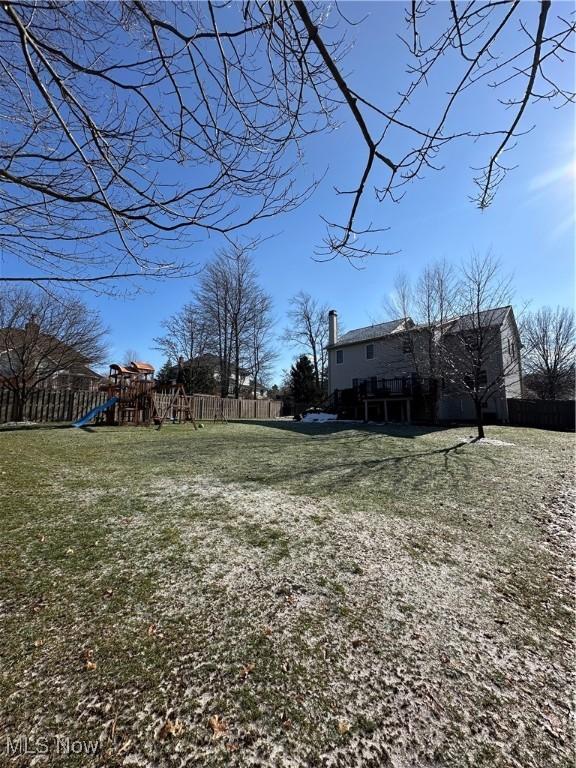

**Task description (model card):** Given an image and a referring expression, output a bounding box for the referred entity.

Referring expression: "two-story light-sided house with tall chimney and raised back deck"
[328,306,522,422]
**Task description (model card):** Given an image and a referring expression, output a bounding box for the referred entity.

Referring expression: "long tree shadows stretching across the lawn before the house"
[145,421,494,495]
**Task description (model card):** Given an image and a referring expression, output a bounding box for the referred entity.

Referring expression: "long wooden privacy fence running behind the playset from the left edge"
[0,389,282,424]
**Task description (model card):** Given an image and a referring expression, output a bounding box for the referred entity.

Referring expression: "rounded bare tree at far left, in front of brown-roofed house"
[0,288,106,421]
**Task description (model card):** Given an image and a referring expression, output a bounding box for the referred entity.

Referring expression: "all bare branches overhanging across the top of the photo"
[0,0,575,286]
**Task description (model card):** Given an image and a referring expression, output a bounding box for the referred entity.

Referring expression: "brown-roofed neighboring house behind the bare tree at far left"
[0,321,102,392]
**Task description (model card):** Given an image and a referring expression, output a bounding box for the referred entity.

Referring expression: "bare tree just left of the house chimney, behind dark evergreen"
[282,291,328,391]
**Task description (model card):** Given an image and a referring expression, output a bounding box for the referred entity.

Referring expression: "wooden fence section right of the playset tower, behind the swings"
[154,394,282,421]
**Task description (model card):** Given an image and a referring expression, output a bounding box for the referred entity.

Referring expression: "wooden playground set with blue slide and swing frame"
[72,361,205,429]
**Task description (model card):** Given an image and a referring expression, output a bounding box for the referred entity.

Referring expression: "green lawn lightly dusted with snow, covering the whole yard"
[0,422,574,768]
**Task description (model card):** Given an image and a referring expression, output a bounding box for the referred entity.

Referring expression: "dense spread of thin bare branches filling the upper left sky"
[0,0,320,286]
